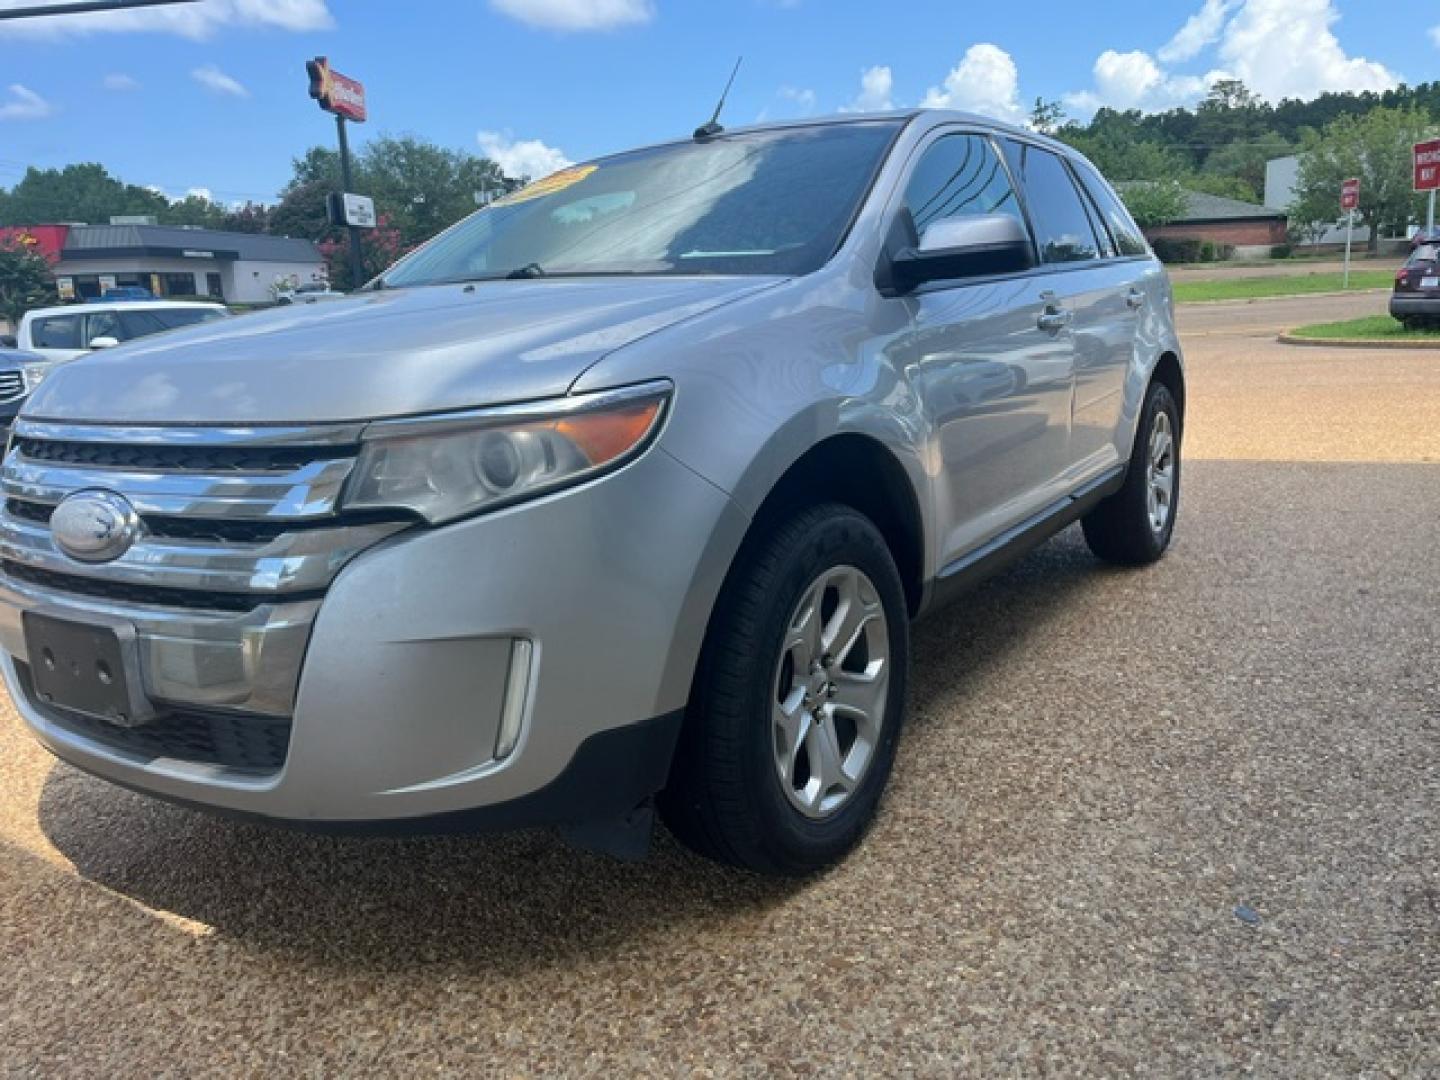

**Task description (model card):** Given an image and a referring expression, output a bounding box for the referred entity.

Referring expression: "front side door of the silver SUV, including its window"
[894,130,1074,566]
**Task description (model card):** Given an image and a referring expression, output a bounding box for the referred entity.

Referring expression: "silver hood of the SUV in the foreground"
[24,276,778,425]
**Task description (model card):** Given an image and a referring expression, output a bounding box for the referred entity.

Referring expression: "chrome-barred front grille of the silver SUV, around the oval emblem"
[0,420,413,730]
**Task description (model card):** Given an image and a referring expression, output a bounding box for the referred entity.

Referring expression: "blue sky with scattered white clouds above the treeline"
[0,0,1440,203]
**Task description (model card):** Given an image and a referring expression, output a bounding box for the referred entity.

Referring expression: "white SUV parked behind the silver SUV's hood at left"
[16,300,230,360]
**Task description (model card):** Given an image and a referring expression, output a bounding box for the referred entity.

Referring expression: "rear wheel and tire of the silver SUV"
[1081,383,1182,566]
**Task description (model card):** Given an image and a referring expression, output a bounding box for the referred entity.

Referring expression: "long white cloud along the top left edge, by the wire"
[0,0,336,40]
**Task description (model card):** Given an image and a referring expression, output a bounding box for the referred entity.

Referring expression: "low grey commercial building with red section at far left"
[4,222,325,304]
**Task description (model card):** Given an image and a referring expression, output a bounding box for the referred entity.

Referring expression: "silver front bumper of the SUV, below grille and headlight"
[8,448,746,827]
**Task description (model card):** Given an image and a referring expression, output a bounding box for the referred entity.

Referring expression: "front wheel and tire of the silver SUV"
[660,504,910,877]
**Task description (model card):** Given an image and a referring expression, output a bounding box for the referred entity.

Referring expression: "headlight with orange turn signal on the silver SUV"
[344,383,671,524]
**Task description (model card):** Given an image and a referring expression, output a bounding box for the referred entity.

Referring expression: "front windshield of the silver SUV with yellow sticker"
[383,121,897,288]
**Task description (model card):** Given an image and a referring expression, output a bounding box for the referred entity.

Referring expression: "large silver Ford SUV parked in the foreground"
[0,112,1185,874]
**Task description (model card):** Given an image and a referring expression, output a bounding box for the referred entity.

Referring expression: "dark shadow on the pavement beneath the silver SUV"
[39,533,1106,972]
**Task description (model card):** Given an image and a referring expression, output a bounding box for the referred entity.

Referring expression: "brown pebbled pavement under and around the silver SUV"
[0,297,1440,1077]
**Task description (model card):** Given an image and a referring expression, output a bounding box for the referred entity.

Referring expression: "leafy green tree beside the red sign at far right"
[1290,107,1433,252]
